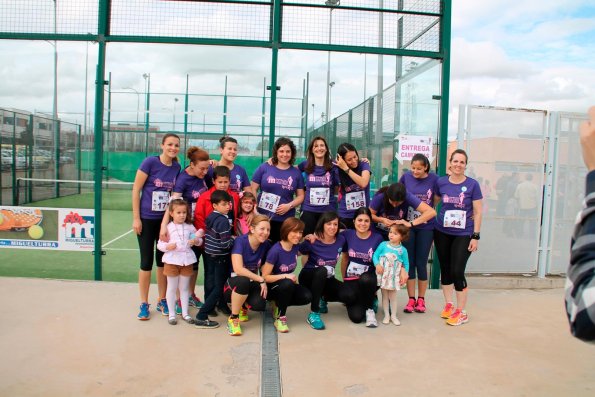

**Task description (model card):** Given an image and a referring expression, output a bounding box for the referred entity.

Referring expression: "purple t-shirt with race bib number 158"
[335,161,372,219]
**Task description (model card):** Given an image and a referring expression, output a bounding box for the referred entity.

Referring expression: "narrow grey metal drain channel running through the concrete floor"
[260,304,281,397]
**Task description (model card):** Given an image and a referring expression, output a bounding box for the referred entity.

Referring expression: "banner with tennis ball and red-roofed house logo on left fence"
[0,206,95,251]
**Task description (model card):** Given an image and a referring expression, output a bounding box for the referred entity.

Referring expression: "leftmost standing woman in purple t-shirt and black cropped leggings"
[132,134,181,320]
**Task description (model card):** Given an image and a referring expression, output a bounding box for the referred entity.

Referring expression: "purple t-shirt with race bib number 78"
[252,163,304,222]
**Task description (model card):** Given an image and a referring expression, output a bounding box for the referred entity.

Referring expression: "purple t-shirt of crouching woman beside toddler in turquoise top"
[341,229,383,280]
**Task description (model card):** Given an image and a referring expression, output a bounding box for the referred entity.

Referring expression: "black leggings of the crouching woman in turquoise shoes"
[299,266,356,313]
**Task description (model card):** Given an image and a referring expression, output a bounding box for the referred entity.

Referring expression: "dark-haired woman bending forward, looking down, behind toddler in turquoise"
[370,182,436,240]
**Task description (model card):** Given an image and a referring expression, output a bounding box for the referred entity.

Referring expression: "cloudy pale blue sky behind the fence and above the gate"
[0,0,595,136]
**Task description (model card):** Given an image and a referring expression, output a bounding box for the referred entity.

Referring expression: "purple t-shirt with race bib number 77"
[298,161,339,213]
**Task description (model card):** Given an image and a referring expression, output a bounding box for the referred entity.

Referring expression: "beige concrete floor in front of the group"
[0,278,595,397]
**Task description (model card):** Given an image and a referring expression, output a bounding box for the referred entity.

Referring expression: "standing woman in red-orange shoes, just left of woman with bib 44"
[399,153,438,313]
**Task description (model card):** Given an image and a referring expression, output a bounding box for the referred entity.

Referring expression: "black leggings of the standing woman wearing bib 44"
[434,230,471,291]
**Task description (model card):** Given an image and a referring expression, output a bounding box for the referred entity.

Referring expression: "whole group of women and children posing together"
[132,134,482,335]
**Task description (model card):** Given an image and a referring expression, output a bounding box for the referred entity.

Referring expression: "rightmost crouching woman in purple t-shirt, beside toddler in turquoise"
[341,207,383,328]
